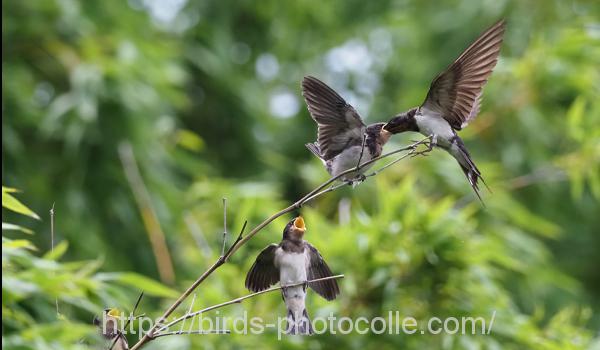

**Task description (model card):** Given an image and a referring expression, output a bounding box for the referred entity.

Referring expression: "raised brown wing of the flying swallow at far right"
[421,20,505,130]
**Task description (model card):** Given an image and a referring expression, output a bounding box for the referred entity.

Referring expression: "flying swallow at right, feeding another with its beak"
[383,20,505,200]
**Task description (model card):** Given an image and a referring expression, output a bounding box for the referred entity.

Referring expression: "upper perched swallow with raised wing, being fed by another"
[302,76,391,184]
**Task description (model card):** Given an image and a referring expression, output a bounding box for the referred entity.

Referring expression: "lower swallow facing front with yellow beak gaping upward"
[246,216,340,334]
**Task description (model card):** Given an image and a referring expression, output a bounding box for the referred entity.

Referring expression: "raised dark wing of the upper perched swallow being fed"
[302,76,366,160]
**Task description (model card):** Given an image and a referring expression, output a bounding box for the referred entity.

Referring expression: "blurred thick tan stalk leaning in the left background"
[119,142,175,284]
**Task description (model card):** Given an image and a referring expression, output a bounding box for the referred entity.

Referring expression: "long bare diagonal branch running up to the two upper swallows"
[131,138,430,350]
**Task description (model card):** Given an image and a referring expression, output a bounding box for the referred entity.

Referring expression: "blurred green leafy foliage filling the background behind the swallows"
[2,0,600,349]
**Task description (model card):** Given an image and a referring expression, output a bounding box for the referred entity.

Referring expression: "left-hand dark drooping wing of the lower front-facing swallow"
[246,243,279,292]
